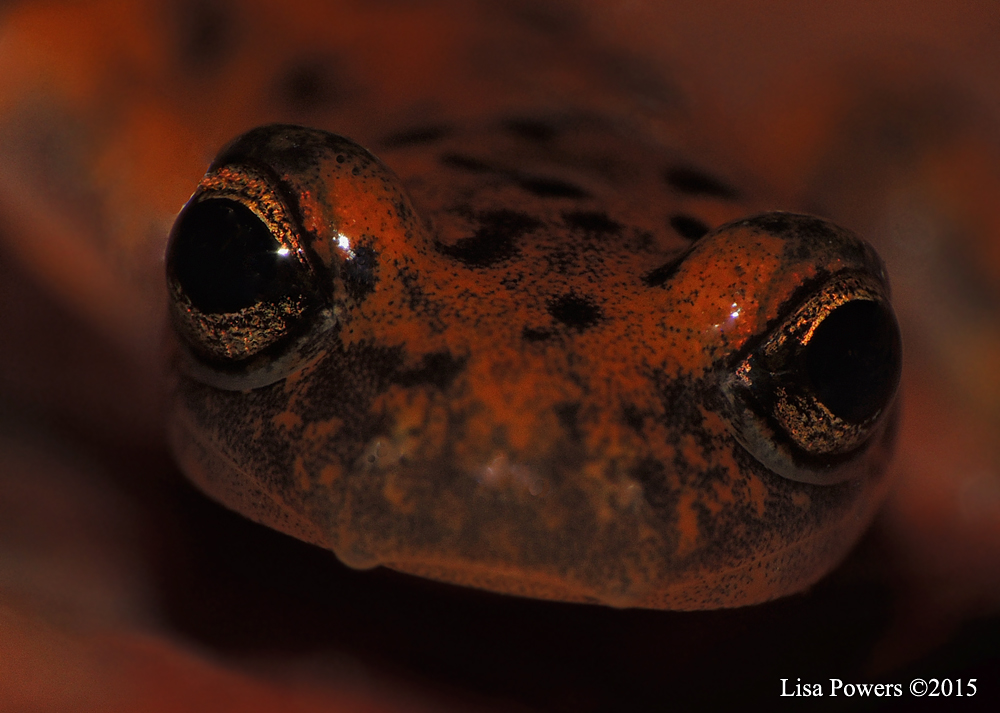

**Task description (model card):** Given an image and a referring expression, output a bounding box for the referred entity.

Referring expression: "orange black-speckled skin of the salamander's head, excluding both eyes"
[173,121,893,609]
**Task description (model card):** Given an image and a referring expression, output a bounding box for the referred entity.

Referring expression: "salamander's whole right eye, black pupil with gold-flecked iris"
[723,274,902,484]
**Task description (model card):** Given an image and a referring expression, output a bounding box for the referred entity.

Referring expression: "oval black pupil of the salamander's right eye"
[805,300,902,424]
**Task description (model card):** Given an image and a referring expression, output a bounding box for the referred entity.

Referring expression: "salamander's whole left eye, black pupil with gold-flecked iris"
[167,167,331,389]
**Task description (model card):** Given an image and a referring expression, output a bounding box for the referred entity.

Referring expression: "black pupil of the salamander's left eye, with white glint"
[167,198,301,314]
